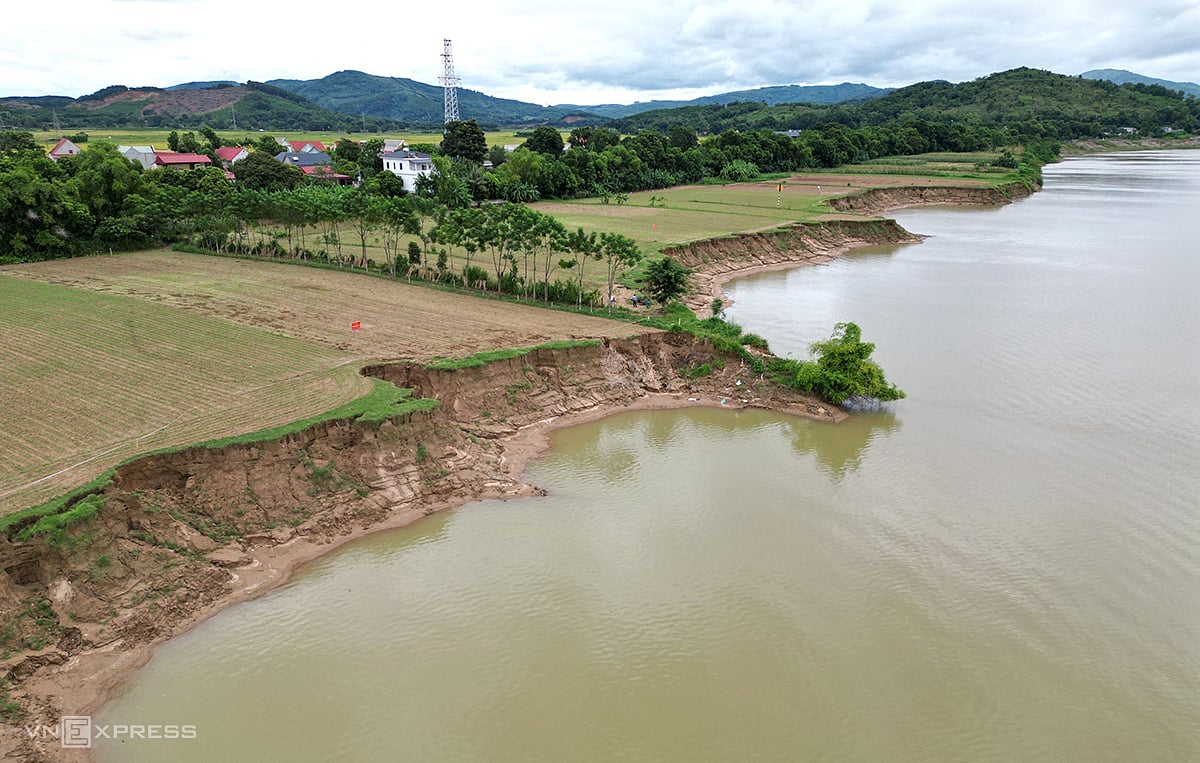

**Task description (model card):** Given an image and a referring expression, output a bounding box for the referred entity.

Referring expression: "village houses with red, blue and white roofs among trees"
[49,138,433,193]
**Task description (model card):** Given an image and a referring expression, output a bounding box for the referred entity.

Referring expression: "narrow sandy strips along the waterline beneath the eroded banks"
[0,179,1032,761]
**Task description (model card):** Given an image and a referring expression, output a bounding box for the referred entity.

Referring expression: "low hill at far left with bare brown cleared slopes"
[0,82,403,131]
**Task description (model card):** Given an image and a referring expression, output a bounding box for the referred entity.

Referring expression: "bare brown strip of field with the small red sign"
[0,251,636,359]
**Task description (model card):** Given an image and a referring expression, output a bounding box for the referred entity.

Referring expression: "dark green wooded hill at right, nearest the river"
[608,68,1200,139]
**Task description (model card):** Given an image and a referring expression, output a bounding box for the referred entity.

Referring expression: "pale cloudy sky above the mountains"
[0,0,1200,104]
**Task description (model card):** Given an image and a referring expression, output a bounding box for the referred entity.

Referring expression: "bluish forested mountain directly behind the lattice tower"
[268,70,595,125]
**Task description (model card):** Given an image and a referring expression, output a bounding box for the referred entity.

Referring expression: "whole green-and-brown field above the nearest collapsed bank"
[0,251,634,513]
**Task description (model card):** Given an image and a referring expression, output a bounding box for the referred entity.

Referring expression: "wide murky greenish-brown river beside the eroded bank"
[96,151,1200,762]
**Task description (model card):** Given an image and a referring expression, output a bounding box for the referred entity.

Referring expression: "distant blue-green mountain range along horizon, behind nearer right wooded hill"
[0,70,1200,132]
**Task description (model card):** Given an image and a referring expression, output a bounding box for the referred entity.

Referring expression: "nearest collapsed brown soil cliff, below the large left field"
[0,332,845,761]
